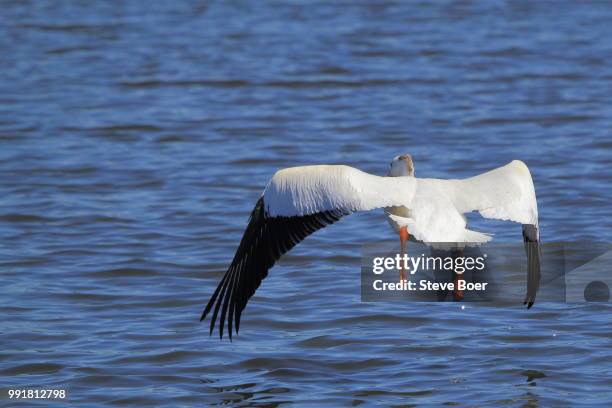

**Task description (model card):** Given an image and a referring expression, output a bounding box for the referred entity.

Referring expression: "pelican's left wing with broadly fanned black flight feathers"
[201,166,416,339]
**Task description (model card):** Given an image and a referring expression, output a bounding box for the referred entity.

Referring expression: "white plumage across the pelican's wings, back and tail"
[263,160,538,243]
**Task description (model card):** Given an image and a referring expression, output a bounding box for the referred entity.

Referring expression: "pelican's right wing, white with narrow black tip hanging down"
[451,160,540,308]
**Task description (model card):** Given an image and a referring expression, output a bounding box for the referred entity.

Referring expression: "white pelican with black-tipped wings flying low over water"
[200,155,540,339]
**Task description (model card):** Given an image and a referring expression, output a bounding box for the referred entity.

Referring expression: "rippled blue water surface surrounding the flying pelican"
[0,1,612,407]
